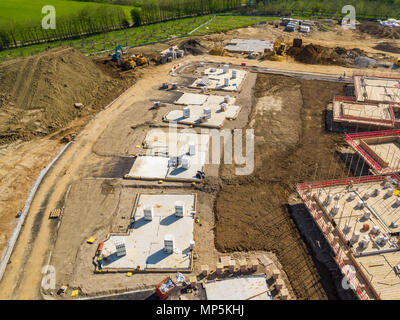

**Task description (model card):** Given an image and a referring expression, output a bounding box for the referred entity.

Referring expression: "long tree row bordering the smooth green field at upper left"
[0,0,242,50]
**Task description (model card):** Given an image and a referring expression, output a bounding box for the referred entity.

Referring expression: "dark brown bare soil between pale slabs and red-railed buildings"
[215,75,347,299]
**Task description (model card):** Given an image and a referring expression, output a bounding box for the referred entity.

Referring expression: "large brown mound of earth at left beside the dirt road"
[0,47,136,144]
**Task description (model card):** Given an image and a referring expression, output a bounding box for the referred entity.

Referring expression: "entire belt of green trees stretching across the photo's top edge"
[0,0,400,50]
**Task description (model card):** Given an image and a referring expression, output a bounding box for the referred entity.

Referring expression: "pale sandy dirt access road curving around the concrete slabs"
[0,52,376,299]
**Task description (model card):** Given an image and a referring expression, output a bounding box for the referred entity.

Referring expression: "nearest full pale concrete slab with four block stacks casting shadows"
[101,194,196,271]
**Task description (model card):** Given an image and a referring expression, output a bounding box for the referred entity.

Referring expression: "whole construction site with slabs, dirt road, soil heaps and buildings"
[0,15,400,300]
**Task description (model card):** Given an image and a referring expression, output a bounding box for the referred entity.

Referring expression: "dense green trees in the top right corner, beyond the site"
[245,0,400,18]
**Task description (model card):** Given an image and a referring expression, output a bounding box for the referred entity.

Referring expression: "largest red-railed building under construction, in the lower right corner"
[297,175,400,300]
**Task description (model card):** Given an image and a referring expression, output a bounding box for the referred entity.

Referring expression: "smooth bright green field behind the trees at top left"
[0,0,132,24]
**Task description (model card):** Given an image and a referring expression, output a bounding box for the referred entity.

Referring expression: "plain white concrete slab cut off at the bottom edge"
[205,275,272,300]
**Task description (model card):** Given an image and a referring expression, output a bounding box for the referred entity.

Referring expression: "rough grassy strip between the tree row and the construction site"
[0,15,273,62]
